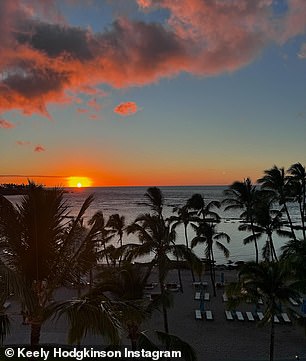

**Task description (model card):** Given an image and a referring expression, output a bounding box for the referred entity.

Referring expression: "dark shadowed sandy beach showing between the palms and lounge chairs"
[5,270,306,361]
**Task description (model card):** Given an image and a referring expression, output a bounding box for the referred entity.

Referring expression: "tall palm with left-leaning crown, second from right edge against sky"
[258,165,296,239]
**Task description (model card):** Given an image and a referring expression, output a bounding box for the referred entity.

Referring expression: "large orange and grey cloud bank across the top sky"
[0,0,306,116]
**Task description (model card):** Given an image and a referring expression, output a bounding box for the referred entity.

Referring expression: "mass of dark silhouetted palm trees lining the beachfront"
[0,163,306,360]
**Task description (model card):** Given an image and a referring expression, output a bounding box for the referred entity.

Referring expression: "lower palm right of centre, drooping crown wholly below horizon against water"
[191,221,230,296]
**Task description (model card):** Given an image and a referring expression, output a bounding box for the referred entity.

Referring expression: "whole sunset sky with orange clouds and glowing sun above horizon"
[0,0,306,186]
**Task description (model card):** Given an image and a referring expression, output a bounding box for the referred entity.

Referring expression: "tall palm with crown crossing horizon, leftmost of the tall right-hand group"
[222,178,259,263]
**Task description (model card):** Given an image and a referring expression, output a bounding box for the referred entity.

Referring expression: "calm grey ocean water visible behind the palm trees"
[7,186,299,264]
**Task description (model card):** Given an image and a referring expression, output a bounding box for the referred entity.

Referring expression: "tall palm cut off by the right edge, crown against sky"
[288,163,306,240]
